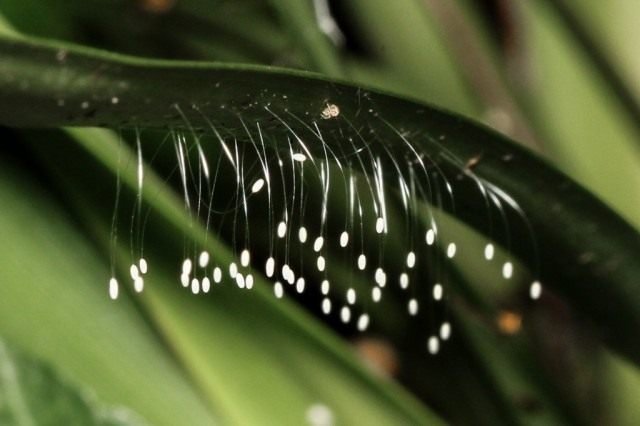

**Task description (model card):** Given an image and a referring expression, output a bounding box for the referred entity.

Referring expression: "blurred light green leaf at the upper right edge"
[522,2,640,229]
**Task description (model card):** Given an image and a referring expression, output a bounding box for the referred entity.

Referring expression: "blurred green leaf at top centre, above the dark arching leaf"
[342,0,482,119]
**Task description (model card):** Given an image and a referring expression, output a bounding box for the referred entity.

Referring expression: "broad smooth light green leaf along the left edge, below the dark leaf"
[0,140,220,425]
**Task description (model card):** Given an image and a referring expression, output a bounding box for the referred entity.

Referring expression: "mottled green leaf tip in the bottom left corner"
[0,340,146,426]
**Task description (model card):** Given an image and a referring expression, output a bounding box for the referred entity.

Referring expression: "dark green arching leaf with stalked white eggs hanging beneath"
[0,35,640,368]
